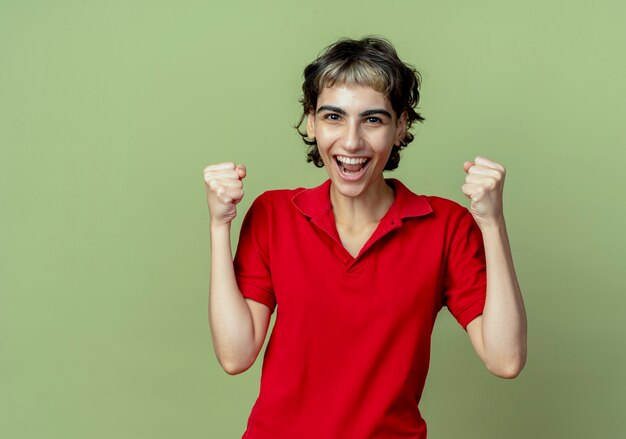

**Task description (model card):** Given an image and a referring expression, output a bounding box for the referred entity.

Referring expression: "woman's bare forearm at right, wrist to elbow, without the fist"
[482,217,527,376]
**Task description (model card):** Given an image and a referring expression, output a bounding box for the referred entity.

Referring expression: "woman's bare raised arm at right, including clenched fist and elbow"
[462,157,527,378]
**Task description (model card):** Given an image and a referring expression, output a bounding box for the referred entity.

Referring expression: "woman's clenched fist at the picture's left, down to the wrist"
[204,162,246,229]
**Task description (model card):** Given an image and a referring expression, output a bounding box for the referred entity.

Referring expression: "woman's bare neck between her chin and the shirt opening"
[330,178,394,228]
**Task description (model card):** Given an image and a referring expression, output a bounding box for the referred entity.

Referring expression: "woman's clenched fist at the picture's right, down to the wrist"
[461,156,506,227]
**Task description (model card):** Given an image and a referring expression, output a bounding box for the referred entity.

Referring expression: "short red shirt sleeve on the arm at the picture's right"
[444,209,487,329]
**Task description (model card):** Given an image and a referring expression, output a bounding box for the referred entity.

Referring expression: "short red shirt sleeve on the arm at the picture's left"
[234,195,276,312]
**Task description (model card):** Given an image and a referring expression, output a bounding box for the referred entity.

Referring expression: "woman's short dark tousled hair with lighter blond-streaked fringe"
[296,37,424,171]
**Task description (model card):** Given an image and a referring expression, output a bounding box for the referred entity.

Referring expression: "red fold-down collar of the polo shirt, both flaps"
[292,178,433,219]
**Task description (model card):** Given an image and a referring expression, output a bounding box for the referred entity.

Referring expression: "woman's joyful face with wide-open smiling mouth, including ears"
[307,84,406,197]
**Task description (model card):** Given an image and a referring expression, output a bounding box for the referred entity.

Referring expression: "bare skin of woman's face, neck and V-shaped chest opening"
[307,84,406,256]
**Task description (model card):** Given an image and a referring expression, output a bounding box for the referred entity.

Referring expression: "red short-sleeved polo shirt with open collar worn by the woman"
[235,179,486,439]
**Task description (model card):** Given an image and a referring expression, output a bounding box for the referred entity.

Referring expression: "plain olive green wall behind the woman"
[0,0,626,439]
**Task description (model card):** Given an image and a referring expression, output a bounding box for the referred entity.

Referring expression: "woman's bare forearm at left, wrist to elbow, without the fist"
[209,224,256,373]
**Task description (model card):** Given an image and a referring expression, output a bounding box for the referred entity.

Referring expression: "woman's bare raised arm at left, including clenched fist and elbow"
[204,163,270,375]
